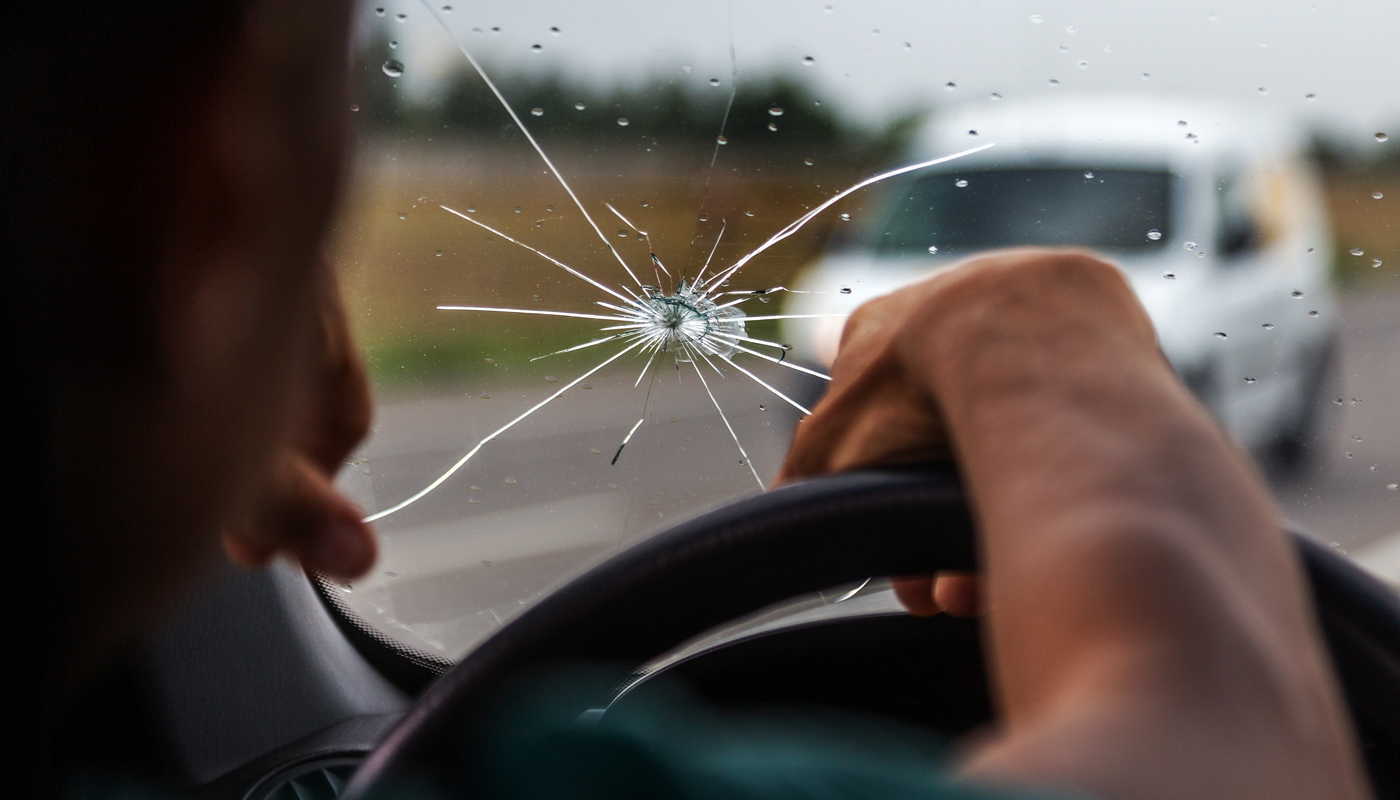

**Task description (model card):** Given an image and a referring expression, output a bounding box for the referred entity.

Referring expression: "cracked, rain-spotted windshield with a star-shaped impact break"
[330,0,1400,660]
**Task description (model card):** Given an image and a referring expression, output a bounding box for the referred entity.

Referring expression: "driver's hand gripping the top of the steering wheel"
[778,249,1142,616]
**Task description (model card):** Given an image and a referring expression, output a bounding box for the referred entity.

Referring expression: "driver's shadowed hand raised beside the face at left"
[224,263,378,579]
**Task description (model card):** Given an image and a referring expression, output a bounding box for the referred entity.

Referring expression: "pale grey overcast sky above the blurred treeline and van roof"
[360,0,1400,147]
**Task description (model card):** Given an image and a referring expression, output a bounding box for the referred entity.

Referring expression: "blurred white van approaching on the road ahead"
[784,97,1337,458]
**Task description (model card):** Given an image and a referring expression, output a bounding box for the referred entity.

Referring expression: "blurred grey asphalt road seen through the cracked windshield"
[330,285,1400,657]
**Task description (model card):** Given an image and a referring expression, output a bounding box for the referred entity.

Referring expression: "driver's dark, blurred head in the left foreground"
[12,0,361,692]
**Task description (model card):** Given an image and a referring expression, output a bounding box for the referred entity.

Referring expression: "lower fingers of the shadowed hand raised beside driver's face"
[224,454,378,579]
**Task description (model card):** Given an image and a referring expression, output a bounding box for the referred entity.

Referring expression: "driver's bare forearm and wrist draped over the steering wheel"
[904,258,1365,799]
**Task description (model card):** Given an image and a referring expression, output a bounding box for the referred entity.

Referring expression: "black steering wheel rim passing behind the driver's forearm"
[343,469,1400,800]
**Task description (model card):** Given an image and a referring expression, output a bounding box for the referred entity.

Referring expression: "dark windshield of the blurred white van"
[872,168,1172,255]
